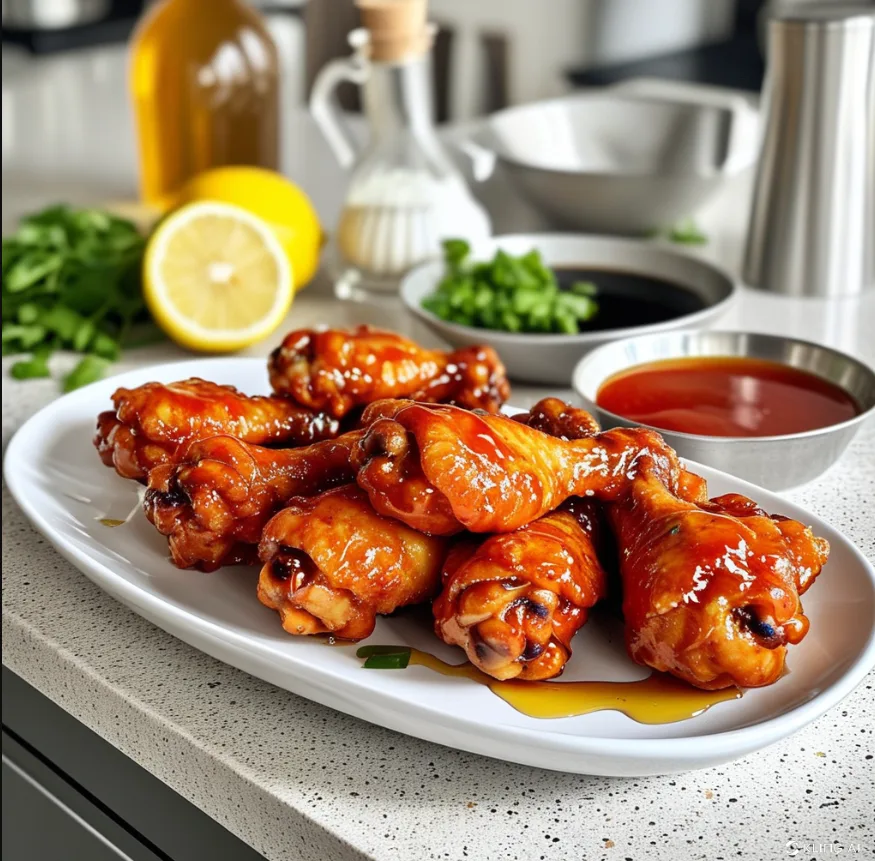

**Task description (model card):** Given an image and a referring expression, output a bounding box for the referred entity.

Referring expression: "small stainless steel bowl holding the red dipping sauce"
[572,331,875,490]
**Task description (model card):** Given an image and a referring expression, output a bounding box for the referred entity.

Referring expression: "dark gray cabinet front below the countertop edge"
[2,667,264,861]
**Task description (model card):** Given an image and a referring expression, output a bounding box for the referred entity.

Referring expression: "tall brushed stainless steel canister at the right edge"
[744,2,875,296]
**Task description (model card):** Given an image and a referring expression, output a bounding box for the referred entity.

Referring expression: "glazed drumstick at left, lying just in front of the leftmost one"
[143,401,408,571]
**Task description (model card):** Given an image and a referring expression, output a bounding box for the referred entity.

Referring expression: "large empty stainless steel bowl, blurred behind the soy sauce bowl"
[475,91,759,235]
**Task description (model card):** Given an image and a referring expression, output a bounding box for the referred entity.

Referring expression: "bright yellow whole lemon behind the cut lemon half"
[176,165,322,290]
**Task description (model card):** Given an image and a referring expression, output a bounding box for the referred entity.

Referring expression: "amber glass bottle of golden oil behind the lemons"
[130,0,279,209]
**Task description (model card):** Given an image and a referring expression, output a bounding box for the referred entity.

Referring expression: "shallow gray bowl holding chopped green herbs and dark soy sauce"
[401,233,737,386]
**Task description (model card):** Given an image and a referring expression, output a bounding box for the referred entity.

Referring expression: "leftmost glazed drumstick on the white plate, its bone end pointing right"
[94,378,339,481]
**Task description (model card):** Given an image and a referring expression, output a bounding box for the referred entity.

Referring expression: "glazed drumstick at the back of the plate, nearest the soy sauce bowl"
[269,326,510,418]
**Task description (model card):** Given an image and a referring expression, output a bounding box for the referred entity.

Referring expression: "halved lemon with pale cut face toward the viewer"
[143,201,295,353]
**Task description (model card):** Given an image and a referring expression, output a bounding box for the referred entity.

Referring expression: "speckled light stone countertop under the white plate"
[3,55,875,861]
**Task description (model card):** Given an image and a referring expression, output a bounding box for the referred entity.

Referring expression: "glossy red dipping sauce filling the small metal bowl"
[596,356,860,437]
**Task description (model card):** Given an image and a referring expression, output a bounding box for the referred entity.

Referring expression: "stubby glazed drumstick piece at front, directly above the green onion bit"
[258,485,447,640]
